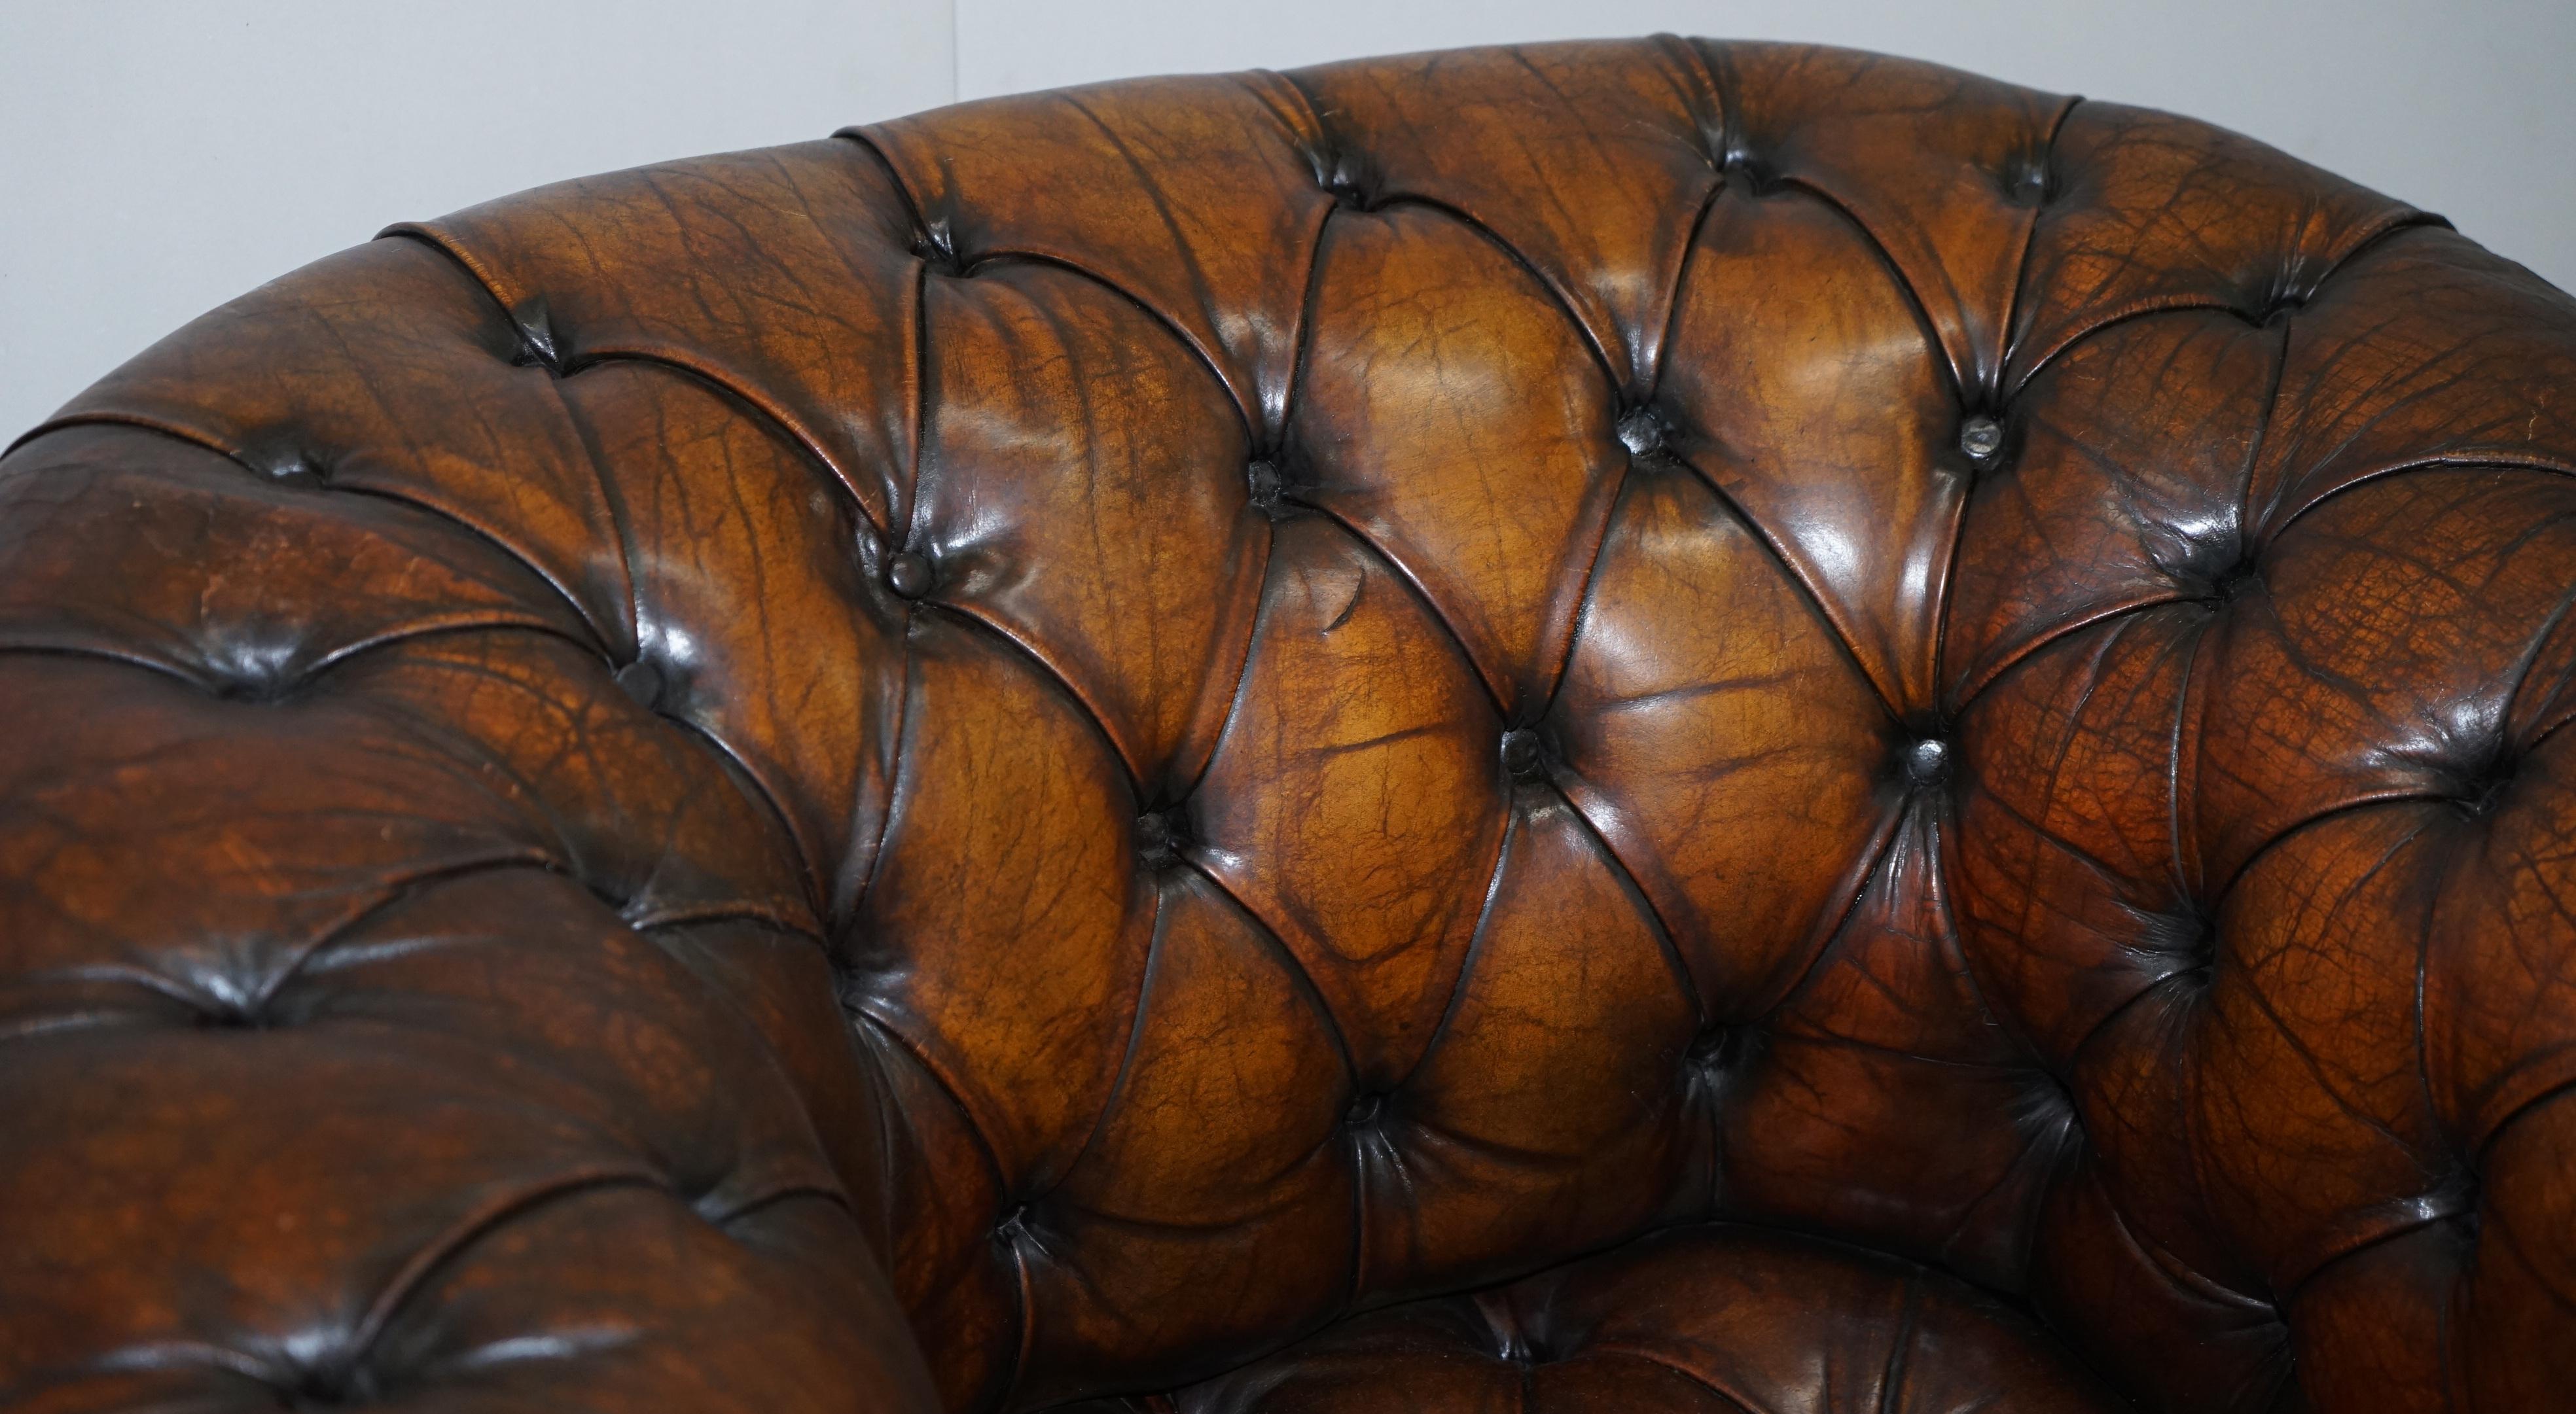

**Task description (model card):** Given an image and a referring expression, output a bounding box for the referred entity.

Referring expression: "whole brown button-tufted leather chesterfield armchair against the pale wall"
[0,39,2576,1414]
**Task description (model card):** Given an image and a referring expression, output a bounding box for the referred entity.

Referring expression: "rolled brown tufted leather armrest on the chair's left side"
[0,425,935,1411]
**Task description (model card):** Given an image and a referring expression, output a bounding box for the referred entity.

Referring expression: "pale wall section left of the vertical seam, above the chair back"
[0,0,956,446]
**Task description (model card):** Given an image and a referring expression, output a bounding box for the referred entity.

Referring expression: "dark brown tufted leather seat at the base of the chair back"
[1147,1224,2128,1414]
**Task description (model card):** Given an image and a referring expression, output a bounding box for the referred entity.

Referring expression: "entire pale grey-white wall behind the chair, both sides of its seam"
[0,0,2576,440]
